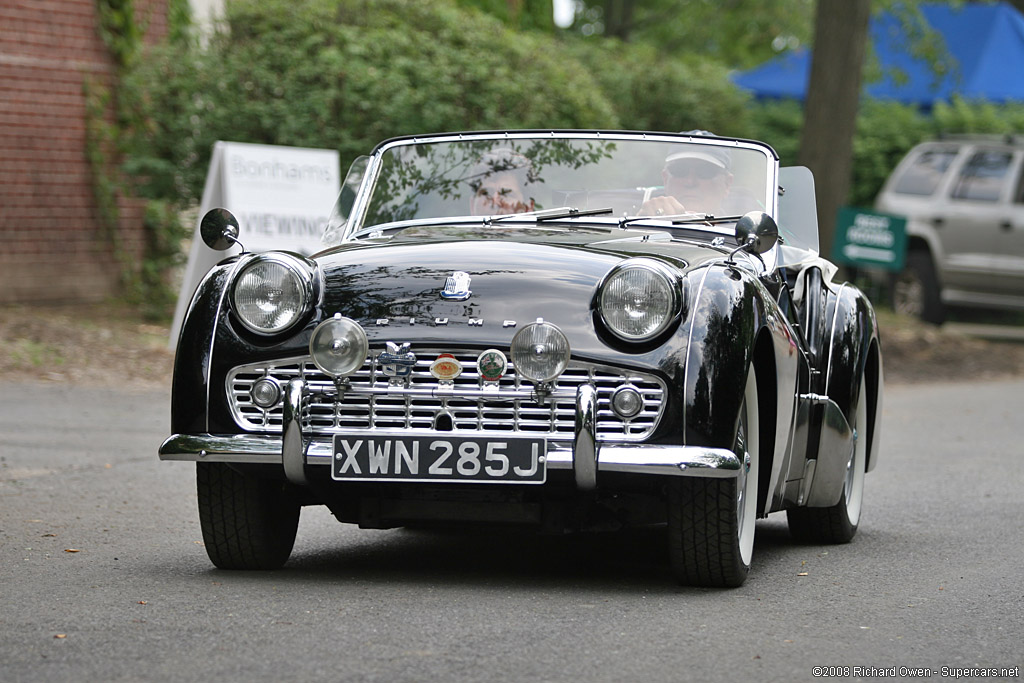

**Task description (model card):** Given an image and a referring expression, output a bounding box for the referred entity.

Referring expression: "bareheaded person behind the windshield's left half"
[469,150,535,216]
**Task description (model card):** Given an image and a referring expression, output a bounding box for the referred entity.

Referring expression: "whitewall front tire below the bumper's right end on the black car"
[668,366,760,587]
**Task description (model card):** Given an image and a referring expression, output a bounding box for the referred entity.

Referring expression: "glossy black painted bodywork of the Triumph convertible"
[172,225,878,504]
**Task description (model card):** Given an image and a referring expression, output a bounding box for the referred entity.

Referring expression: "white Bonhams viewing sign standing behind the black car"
[170,142,341,348]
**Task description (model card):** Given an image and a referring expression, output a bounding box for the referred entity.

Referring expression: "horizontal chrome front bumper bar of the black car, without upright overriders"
[160,431,739,478]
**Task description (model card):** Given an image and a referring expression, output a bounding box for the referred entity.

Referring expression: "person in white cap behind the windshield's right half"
[640,145,732,216]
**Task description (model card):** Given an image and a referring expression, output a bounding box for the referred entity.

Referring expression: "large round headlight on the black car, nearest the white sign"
[233,257,309,335]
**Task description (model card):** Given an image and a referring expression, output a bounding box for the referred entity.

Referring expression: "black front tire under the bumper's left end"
[196,463,300,569]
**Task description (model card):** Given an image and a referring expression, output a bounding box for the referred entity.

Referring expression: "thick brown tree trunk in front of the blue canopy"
[798,0,870,258]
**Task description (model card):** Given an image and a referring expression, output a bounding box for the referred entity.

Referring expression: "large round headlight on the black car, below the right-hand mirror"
[598,259,679,342]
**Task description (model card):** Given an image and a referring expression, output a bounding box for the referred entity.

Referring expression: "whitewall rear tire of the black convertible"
[785,378,868,544]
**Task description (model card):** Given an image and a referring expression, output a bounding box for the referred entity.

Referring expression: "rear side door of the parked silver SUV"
[933,145,1019,301]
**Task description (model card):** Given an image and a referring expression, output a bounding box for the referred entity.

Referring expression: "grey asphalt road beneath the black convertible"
[0,380,1024,683]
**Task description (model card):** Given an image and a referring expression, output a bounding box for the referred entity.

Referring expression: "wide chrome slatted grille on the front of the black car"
[226,348,665,441]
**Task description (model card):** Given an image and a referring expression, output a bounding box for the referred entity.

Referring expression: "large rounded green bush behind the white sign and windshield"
[127,0,620,202]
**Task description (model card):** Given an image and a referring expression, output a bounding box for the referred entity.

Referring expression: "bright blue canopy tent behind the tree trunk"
[732,2,1024,109]
